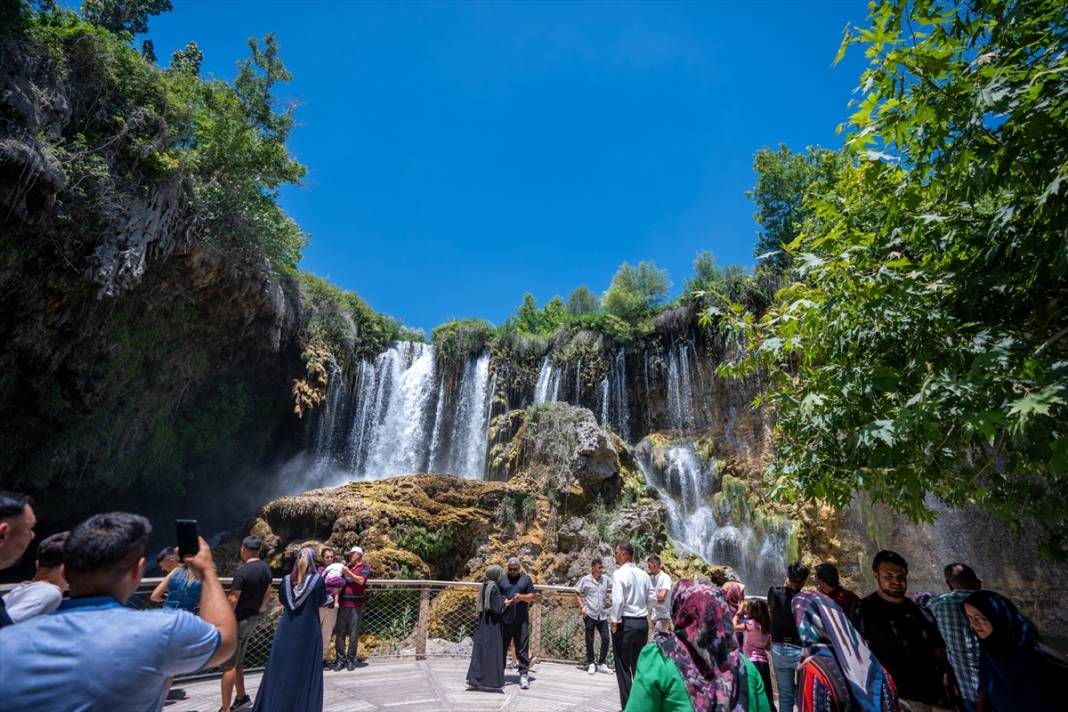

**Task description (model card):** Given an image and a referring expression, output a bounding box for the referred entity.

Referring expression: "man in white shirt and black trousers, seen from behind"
[609,541,654,709]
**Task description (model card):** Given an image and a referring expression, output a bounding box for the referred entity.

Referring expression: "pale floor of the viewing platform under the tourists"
[163,658,619,712]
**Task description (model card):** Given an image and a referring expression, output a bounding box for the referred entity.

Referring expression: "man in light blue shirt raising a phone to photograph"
[0,512,236,712]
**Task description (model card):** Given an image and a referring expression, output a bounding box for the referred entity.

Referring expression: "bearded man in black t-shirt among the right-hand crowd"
[852,551,952,712]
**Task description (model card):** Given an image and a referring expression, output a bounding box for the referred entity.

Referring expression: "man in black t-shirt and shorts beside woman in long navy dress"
[219,536,271,712]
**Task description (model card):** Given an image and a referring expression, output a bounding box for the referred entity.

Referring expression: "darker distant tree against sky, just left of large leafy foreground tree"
[745,144,846,273]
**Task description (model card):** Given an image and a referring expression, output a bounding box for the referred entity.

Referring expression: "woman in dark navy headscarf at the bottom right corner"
[961,591,1068,712]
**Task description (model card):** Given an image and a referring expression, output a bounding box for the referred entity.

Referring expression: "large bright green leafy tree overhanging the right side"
[732,0,1068,558]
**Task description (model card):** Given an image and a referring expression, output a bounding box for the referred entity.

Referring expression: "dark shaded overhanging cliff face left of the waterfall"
[0,29,302,528]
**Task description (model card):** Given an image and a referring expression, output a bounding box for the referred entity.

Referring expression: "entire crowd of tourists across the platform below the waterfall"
[0,491,1068,712]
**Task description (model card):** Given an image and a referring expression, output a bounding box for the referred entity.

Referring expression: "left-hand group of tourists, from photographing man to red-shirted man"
[0,491,371,712]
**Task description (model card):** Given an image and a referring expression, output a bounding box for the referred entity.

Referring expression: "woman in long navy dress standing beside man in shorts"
[254,547,327,712]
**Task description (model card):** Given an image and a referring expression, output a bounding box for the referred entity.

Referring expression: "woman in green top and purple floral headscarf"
[626,579,769,712]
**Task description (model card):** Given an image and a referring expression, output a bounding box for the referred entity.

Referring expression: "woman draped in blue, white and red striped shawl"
[791,591,898,712]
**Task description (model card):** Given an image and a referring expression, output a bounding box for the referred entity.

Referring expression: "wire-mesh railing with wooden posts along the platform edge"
[18,579,611,677]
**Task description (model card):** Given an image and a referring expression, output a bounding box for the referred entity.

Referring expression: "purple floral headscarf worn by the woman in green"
[656,579,748,712]
